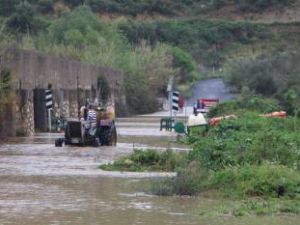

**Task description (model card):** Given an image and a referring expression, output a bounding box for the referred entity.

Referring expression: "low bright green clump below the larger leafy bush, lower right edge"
[211,164,300,198]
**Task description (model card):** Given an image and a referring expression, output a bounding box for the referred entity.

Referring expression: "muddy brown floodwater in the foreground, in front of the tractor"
[0,134,300,225]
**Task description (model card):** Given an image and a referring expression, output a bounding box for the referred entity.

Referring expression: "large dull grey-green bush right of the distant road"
[227,51,300,114]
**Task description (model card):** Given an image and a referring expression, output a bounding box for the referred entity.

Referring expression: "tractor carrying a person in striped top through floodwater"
[55,106,117,147]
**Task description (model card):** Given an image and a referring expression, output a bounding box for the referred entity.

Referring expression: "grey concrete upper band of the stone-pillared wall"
[1,48,122,90]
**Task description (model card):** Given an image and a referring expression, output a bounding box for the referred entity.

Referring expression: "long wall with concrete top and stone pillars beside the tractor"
[0,48,125,136]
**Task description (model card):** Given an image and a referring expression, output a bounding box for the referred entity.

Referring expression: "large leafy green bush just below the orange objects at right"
[189,114,300,171]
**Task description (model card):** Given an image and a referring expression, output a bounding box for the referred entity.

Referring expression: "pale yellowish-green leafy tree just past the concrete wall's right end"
[124,41,176,113]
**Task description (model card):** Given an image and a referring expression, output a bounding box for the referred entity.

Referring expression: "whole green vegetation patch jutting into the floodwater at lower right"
[102,96,300,216]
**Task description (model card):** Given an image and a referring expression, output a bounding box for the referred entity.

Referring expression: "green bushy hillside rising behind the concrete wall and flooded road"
[0,0,300,113]
